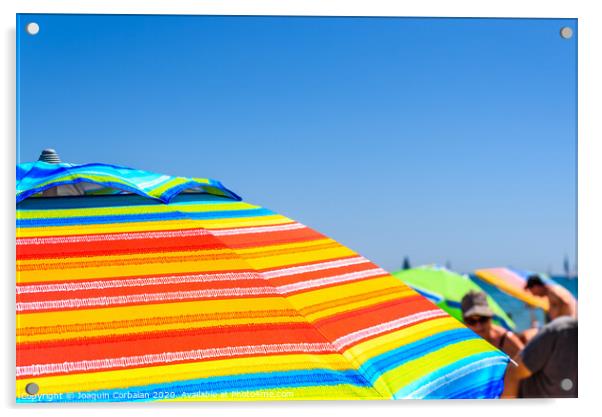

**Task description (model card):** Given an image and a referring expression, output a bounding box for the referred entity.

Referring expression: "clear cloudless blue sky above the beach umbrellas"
[17,15,577,271]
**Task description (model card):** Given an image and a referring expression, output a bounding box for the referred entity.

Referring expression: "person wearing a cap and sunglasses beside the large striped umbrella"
[461,291,523,358]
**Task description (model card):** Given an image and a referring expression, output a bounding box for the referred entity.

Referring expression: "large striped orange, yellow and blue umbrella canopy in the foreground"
[17,162,508,402]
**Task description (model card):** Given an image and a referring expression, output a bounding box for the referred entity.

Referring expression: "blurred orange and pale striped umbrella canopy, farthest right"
[475,268,574,312]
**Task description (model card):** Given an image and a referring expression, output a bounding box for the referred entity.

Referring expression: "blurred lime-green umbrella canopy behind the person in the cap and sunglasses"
[393,266,516,330]
